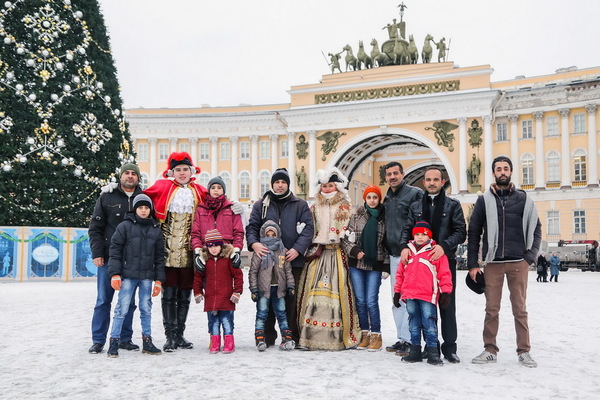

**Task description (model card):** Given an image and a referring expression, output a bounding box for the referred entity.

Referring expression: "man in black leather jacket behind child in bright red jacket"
[400,167,467,364]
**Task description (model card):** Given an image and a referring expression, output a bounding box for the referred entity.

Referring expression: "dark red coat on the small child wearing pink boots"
[194,244,244,311]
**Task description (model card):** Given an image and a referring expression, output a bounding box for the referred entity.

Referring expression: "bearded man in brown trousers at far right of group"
[467,156,542,368]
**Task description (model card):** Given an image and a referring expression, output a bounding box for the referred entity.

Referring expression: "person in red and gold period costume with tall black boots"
[144,152,207,352]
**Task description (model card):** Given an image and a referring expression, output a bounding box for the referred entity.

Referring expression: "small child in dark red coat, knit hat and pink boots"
[194,229,244,354]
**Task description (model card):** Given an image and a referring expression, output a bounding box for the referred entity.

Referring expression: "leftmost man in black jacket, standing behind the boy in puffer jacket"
[88,164,142,354]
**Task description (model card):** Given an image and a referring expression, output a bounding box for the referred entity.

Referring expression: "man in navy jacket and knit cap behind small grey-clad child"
[246,168,314,346]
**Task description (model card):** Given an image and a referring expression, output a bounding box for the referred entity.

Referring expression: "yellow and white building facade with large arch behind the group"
[126,62,600,242]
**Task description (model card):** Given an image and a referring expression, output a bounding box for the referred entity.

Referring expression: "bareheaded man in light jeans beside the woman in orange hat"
[383,161,423,356]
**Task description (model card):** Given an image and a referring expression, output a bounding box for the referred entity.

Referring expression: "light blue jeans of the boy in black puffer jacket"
[110,278,154,339]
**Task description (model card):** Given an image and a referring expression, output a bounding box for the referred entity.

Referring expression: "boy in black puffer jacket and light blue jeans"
[108,194,165,357]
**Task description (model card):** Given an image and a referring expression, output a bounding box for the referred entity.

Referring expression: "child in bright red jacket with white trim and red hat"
[394,221,452,365]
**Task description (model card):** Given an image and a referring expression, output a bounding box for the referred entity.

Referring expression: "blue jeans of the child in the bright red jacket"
[406,299,438,349]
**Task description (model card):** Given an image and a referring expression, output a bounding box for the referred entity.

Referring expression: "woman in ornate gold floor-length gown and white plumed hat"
[298,168,361,350]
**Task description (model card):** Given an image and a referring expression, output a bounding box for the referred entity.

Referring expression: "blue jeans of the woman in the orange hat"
[350,267,381,333]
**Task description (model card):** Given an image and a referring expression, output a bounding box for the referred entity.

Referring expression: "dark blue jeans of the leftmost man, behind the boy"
[92,264,136,344]
